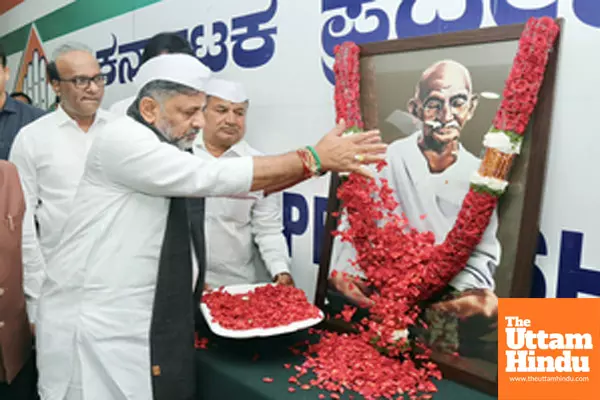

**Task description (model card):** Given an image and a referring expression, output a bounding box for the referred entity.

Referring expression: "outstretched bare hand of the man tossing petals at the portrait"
[315,121,387,177]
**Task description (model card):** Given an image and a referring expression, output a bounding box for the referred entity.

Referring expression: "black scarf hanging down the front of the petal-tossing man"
[127,100,206,400]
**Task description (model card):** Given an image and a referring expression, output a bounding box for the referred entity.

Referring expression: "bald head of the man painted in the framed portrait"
[408,60,478,146]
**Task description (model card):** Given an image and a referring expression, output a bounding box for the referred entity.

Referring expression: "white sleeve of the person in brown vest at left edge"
[9,132,46,323]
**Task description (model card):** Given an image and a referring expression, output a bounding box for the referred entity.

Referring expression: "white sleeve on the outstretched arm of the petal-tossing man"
[97,127,254,197]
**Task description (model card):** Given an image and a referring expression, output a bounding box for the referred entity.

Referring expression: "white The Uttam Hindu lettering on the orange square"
[504,316,594,372]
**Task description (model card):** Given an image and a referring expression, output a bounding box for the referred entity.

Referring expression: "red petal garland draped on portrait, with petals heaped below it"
[293,17,558,398]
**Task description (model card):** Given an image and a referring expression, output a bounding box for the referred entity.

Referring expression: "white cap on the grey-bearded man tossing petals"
[134,53,211,92]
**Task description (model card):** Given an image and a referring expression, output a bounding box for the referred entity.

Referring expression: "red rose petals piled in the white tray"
[202,285,321,330]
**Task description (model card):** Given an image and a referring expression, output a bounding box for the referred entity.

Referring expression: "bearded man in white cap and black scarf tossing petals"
[37,54,386,400]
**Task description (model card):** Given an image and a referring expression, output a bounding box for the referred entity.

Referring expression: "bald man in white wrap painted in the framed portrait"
[330,60,501,317]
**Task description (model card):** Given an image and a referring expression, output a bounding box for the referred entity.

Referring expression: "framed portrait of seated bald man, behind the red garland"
[315,21,561,394]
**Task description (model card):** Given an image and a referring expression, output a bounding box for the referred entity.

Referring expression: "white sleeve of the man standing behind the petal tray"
[251,193,290,277]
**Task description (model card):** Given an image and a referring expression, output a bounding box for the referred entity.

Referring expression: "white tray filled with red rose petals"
[200,283,325,339]
